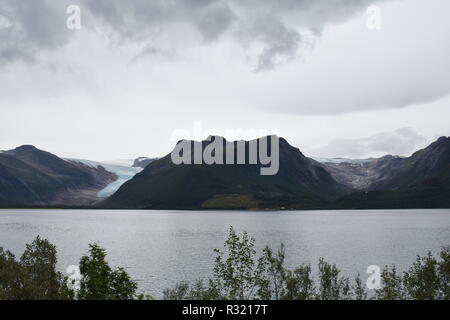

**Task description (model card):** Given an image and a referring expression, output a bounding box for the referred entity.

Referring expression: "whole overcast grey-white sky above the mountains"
[0,0,450,160]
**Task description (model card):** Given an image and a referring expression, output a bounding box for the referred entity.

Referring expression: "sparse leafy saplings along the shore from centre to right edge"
[164,228,450,300]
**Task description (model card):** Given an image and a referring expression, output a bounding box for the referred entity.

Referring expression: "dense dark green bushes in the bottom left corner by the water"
[0,237,144,300]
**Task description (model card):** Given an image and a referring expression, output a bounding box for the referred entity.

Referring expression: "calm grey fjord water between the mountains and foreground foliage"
[0,209,450,297]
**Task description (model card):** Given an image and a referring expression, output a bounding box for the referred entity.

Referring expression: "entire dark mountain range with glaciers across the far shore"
[0,137,450,210]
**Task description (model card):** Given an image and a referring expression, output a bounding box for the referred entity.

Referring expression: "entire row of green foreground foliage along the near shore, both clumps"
[0,228,450,300]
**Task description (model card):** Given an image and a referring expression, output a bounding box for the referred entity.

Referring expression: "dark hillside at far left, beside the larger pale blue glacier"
[0,145,116,206]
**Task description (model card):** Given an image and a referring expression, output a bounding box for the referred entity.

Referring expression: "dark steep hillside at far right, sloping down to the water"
[334,137,450,208]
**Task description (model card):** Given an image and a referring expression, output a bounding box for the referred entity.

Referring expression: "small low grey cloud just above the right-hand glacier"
[308,127,428,158]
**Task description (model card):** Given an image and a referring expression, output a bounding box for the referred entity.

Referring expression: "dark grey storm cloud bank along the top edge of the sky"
[0,0,380,69]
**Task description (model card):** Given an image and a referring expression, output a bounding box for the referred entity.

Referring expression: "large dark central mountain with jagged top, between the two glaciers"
[103,138,348,209]
